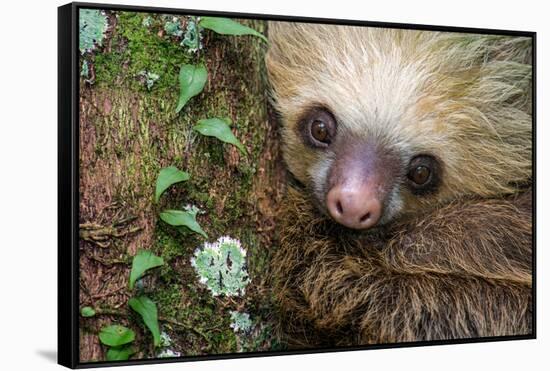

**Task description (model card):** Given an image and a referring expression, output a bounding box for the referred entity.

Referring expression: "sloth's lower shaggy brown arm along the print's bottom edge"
[300,253,531,344]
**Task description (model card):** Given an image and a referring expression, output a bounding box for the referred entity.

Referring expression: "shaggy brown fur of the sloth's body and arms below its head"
[273,188,532,346]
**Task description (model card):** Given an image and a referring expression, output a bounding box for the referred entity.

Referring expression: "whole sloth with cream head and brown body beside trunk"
[266,22,533,348]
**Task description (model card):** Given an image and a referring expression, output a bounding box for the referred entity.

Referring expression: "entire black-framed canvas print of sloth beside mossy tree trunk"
[58,3,536,368]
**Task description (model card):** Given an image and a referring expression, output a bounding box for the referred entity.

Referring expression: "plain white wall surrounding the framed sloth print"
[0,0,550,371]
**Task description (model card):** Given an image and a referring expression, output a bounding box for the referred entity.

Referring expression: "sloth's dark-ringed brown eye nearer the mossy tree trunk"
[300,108,336,148]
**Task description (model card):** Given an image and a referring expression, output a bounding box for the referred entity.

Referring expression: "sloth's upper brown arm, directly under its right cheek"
[382,191,533,286]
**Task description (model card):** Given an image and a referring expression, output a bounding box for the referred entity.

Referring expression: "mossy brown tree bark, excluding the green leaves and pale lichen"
[80,12,284,362]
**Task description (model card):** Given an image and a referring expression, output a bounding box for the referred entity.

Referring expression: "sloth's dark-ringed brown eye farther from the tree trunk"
[407,155,440,195]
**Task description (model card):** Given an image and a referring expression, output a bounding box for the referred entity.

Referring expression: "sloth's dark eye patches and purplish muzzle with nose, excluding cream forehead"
[295,107,442,229]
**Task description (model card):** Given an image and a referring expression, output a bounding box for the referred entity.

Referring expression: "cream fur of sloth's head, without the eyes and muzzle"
[266,22,532,222]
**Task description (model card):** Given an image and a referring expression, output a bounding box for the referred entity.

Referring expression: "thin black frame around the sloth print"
[57,2,537,368]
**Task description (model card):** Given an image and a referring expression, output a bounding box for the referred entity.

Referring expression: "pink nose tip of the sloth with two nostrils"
[327,185,382,229]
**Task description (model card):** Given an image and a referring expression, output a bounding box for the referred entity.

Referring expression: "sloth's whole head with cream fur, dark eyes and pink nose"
[266,22,532,229]
